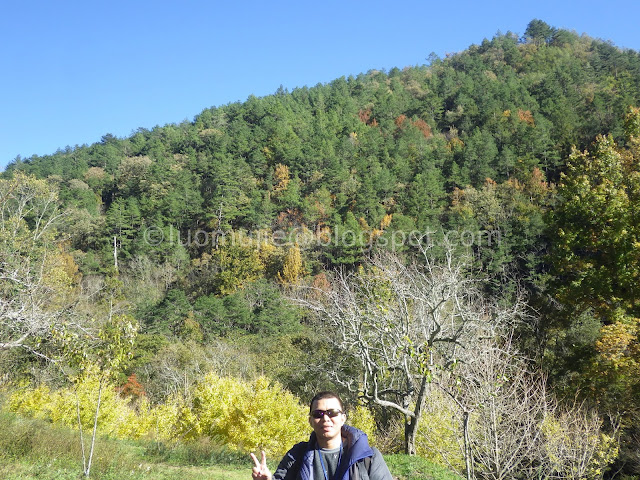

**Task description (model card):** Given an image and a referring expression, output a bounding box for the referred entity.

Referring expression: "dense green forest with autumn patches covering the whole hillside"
[0,20,640,479]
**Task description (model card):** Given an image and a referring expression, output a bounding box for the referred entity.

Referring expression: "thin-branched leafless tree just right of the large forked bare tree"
[448,335,552,480]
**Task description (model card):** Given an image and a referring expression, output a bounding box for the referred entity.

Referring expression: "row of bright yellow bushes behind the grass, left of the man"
[5,374,310,457]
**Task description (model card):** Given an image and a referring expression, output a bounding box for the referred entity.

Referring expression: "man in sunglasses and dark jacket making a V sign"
[251,392,393,480]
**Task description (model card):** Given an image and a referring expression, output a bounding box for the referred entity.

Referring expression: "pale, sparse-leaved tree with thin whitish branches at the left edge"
[0,173,69,355]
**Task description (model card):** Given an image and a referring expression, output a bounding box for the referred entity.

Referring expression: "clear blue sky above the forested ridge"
[0,0,640,169]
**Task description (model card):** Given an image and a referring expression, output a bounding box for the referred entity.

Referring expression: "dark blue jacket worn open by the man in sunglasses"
[273,425,393,480]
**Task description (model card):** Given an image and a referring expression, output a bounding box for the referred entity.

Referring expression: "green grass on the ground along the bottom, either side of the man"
[0,412,460,480]
